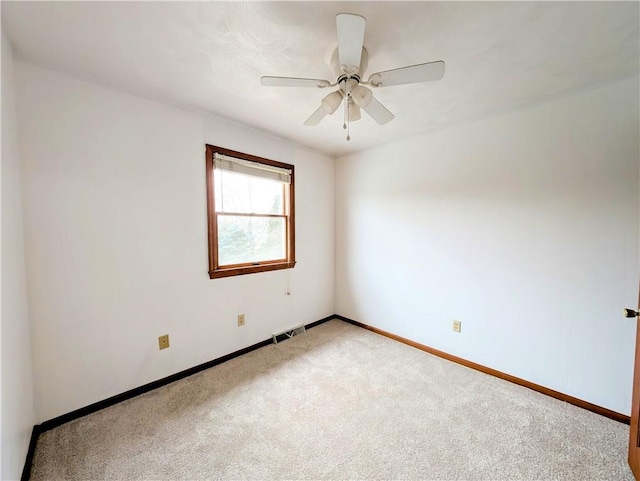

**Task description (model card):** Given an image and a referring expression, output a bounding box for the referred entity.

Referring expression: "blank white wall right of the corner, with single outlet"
[336,78,639,414]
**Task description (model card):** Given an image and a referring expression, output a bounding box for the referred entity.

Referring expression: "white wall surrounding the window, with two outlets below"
[16,63,335,421]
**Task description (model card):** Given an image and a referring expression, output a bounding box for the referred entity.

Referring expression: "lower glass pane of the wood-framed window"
[217,215,286,266]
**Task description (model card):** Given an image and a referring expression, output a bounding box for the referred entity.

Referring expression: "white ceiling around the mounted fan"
[2,1,640,155]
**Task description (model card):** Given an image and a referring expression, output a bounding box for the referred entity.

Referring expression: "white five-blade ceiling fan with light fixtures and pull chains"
[260,13,444,140]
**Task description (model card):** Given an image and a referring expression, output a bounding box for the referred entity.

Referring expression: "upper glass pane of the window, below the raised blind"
[214,170,284,214]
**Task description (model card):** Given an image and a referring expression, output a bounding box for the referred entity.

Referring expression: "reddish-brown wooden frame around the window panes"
[205,144,296,279]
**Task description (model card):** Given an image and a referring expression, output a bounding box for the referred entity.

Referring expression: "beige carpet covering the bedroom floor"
[32,320,633,480]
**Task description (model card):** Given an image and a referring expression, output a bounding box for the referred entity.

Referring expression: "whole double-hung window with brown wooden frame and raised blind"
[206,145,295,279]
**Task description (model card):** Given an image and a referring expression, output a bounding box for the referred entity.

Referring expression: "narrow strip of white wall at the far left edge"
[0,32,35,480]
